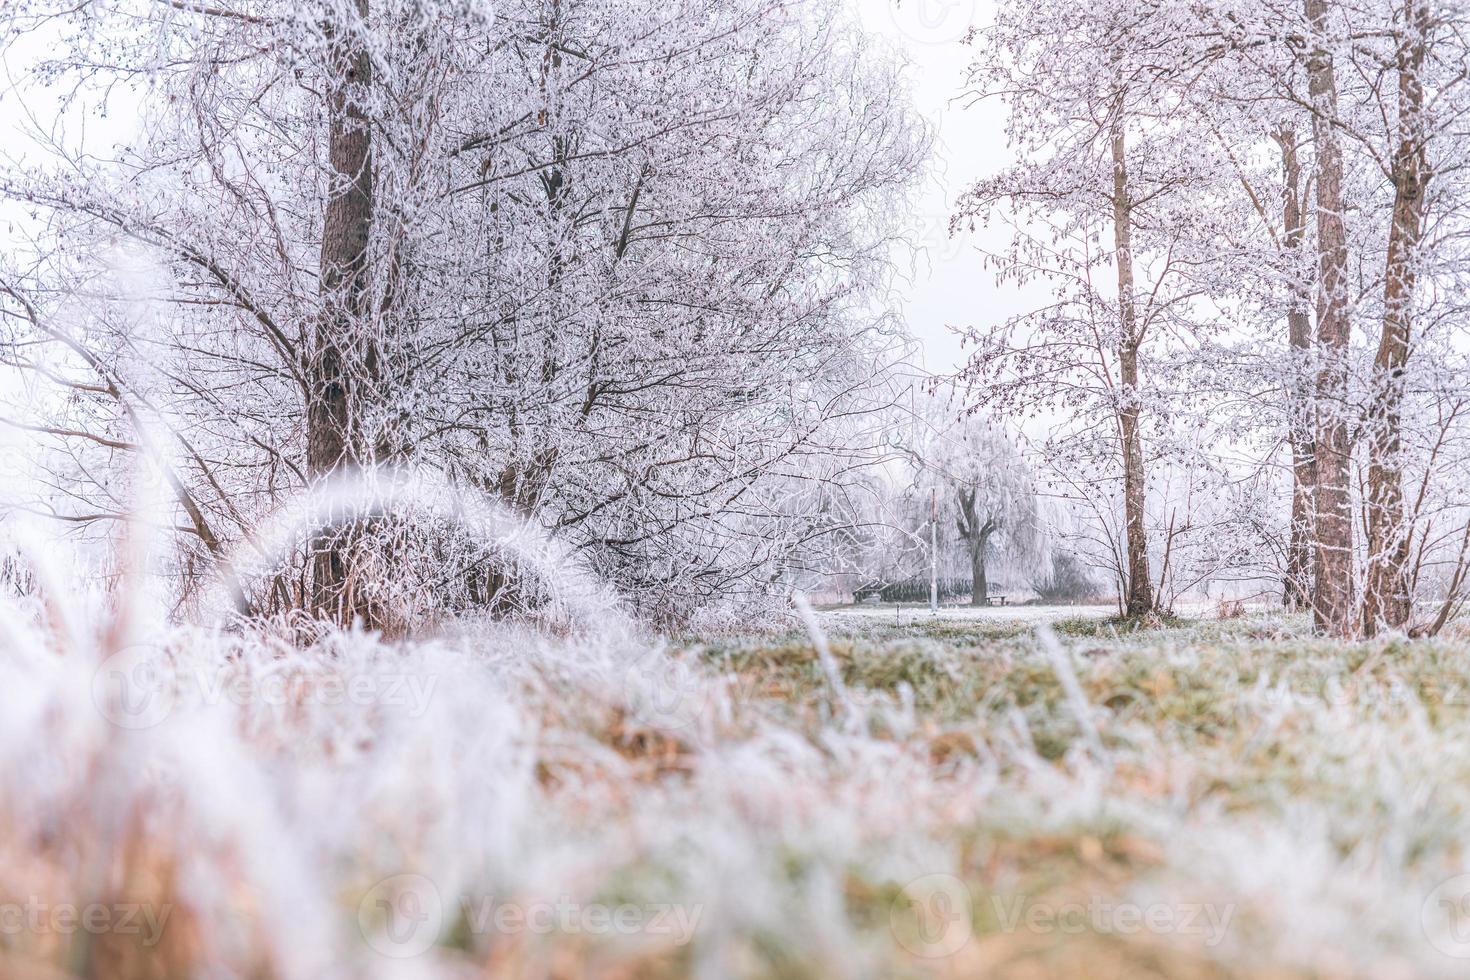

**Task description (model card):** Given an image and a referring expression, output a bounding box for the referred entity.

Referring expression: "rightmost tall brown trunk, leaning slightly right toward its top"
[1363,0,1429,636]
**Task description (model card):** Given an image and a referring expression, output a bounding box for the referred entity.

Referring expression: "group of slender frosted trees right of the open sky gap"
[954,0,1470,638]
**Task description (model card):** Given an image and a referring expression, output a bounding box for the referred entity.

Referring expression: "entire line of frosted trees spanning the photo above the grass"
[0,0,1470,636]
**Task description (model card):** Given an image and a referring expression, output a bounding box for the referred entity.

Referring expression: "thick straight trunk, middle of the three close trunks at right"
[1304,0,1355,636]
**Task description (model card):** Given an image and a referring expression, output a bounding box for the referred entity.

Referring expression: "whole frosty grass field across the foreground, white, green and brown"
[0,611,1470,979]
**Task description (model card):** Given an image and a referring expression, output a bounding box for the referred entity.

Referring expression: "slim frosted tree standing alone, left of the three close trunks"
[954,0,1240,616]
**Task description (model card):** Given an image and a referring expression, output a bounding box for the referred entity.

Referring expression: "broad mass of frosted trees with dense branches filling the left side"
[3,0,926,628]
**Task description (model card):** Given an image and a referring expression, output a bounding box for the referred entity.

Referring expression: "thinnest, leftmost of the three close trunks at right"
[1276,126,1317,611]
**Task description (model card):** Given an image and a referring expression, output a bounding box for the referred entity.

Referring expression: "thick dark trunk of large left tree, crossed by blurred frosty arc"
[306,0,373,623]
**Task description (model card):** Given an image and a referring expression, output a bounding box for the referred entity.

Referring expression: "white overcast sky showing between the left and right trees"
[0,0,1025,373]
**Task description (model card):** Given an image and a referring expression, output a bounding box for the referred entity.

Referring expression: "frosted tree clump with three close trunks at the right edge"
[1204,0,1466,636]
